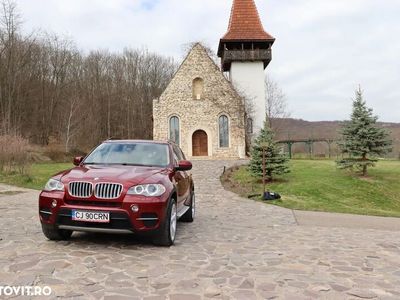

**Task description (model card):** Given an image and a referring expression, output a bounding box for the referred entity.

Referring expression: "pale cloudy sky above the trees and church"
[16,0,400,122]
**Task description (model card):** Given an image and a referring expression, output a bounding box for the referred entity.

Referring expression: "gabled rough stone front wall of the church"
[153,44,245,158]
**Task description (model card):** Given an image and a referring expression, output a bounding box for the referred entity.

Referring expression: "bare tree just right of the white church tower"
[265,76,290,131]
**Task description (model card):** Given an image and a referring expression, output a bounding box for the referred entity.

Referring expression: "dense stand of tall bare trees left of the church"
[0,0,176,151]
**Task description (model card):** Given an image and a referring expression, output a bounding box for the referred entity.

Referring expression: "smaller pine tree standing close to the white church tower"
[249,125,290,180]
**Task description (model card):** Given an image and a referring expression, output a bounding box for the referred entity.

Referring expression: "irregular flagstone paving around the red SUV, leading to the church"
[0,161,400,300]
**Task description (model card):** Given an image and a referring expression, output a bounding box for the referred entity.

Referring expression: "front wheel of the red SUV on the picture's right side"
[153,199,178,247]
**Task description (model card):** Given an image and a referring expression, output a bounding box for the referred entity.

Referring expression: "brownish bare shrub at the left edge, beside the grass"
[0,135,30,174]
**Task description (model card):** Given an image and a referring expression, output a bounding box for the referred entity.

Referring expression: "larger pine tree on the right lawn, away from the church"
[337,88,392,176]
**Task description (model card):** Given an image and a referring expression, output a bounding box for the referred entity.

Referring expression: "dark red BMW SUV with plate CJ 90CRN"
[39,140,195,246]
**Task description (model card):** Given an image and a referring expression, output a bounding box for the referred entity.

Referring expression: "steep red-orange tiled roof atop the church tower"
[222,0,274,41]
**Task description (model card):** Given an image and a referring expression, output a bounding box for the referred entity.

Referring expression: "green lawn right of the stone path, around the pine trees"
[222,160,400,217]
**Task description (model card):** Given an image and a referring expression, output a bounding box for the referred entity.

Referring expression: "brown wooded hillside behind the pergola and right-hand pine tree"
[272,118,400,158]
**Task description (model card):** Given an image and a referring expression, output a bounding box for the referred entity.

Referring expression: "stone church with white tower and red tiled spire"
[153,0,274,158]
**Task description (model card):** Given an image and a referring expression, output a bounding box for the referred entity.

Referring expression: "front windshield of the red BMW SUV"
[83,142,169,167]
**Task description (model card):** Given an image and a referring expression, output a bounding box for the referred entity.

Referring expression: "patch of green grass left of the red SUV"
[0,163,72,190]
